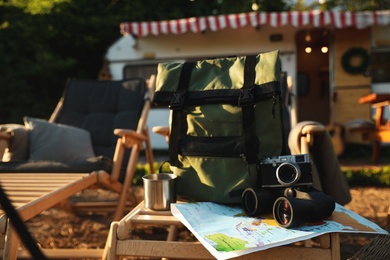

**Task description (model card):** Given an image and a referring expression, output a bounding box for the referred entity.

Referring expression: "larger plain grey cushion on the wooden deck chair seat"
[24,117,95,162]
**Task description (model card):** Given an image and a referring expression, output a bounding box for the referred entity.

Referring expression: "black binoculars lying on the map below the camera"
[242,187,335,228]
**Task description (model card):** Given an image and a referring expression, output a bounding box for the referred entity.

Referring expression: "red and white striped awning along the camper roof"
[120,10,390,37]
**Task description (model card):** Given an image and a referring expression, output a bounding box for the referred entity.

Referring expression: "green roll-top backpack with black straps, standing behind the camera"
[153,51,286,203]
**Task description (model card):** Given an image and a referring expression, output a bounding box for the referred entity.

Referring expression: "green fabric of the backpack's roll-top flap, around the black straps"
[153,51,280,106]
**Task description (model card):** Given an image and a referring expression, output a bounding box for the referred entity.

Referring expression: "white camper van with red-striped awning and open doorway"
[105,11,390,149]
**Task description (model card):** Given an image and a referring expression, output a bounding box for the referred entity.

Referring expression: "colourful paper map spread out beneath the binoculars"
[171,202,387,259]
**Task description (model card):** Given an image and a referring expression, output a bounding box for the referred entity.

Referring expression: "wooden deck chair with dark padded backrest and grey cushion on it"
[0,75,155,259]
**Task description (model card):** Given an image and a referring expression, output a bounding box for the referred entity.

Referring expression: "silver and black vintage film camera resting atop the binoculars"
[258,154,312,188]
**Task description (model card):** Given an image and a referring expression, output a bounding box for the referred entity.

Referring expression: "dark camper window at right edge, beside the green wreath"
[370,50,390,83]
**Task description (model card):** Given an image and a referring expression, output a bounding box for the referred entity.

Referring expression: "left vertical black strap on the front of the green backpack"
[169,62,195,167]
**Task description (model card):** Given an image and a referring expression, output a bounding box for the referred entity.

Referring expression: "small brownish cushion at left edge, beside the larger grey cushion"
[0,124,29,162]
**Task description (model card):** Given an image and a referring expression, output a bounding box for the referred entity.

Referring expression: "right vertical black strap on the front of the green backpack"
[238,56,259,164]
